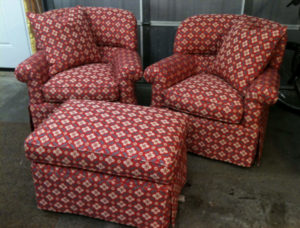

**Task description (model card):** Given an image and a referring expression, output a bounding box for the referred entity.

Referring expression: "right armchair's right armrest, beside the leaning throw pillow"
[245,67,280,105]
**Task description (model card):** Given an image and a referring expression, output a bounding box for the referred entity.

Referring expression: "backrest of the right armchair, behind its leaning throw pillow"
[174,14,287,69]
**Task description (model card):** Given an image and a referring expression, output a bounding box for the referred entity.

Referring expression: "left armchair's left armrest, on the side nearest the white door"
[15,51,50,83]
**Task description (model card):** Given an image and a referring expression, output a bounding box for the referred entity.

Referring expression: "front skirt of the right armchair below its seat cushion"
[187,116,259,167]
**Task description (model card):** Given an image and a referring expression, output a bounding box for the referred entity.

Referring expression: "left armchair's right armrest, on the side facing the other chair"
[111,48,143,81]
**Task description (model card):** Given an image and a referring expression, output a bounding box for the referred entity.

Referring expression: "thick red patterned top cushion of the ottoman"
[25,100,187,183]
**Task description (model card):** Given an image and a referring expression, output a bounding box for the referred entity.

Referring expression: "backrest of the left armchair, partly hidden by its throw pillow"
[36,7,137,50]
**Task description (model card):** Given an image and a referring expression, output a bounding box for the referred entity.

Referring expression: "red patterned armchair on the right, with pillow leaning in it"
[144,15,287,167]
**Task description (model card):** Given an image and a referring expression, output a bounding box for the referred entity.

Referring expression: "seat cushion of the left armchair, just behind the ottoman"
[43,63,119,102]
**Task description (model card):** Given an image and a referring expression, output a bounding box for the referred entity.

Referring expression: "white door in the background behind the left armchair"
[0,0,31,68]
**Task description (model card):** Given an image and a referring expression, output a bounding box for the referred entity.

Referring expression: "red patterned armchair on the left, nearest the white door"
[15,6,142,127]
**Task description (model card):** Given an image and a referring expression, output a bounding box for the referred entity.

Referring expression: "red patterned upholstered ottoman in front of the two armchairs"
[25,100,187,227]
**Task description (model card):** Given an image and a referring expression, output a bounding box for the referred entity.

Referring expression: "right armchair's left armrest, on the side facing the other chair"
[144,54,196,88]
